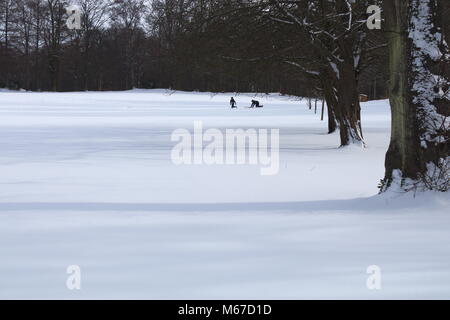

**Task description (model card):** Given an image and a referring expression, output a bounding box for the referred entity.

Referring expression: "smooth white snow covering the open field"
[0,90,450,299]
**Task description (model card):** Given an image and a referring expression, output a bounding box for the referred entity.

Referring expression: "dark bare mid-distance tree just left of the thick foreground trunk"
[265,0,380,146]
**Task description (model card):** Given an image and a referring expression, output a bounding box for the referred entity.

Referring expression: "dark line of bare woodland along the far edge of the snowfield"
[0,0,387,98]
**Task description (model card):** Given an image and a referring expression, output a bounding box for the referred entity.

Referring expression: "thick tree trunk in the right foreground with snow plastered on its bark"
[382,0,450,191]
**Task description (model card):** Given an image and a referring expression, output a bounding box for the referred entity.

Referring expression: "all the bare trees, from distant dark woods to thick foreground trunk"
[0,0,450,189]
